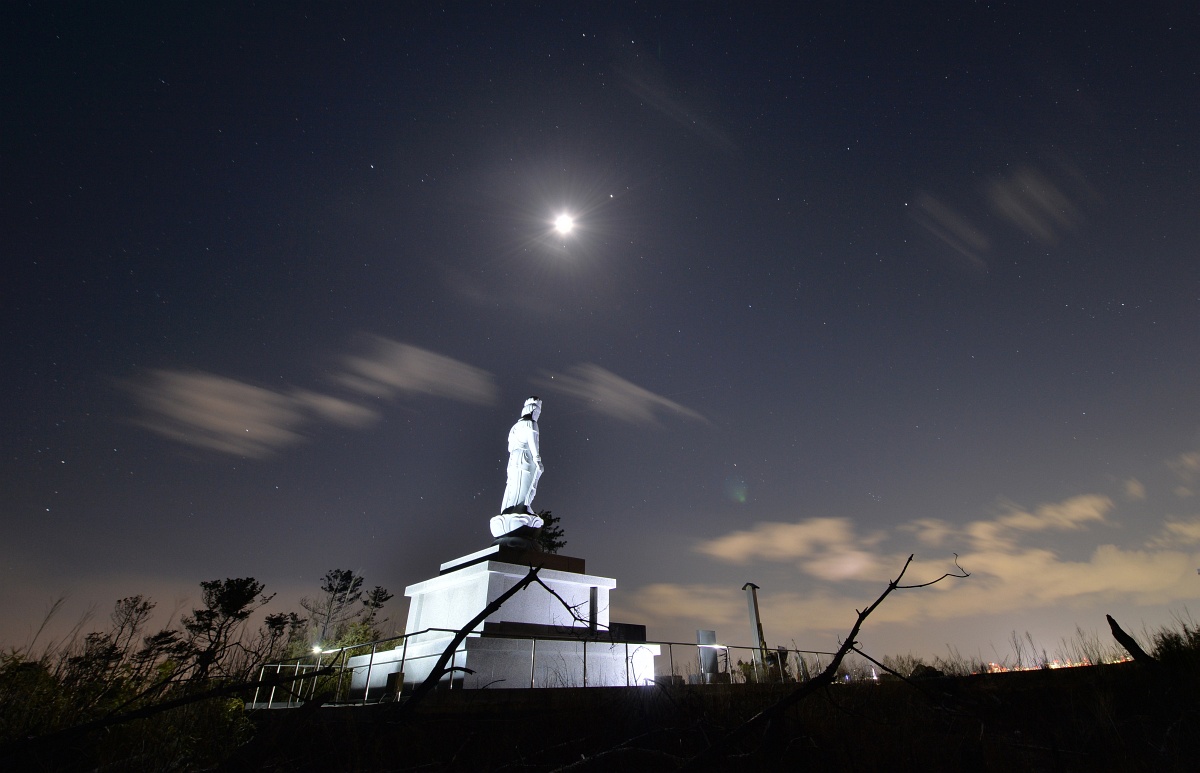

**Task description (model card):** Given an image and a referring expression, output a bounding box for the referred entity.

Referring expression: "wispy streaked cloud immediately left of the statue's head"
[335,336,496,405]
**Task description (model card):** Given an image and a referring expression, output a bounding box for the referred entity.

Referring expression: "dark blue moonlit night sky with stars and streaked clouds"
[0,1,1200,659]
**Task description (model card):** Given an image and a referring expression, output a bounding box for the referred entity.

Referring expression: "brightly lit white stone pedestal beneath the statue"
[349,546,659,700]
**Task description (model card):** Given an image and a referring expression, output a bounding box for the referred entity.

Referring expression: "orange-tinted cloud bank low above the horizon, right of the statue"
[632,495,1200,634]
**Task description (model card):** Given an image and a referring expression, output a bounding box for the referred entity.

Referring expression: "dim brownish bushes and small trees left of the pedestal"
[0,569,390,771]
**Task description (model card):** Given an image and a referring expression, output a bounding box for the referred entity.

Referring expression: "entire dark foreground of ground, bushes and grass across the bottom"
[0,561,1200,772]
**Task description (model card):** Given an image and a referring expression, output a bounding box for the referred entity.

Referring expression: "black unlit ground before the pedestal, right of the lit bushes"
[238,664,1200,773]
